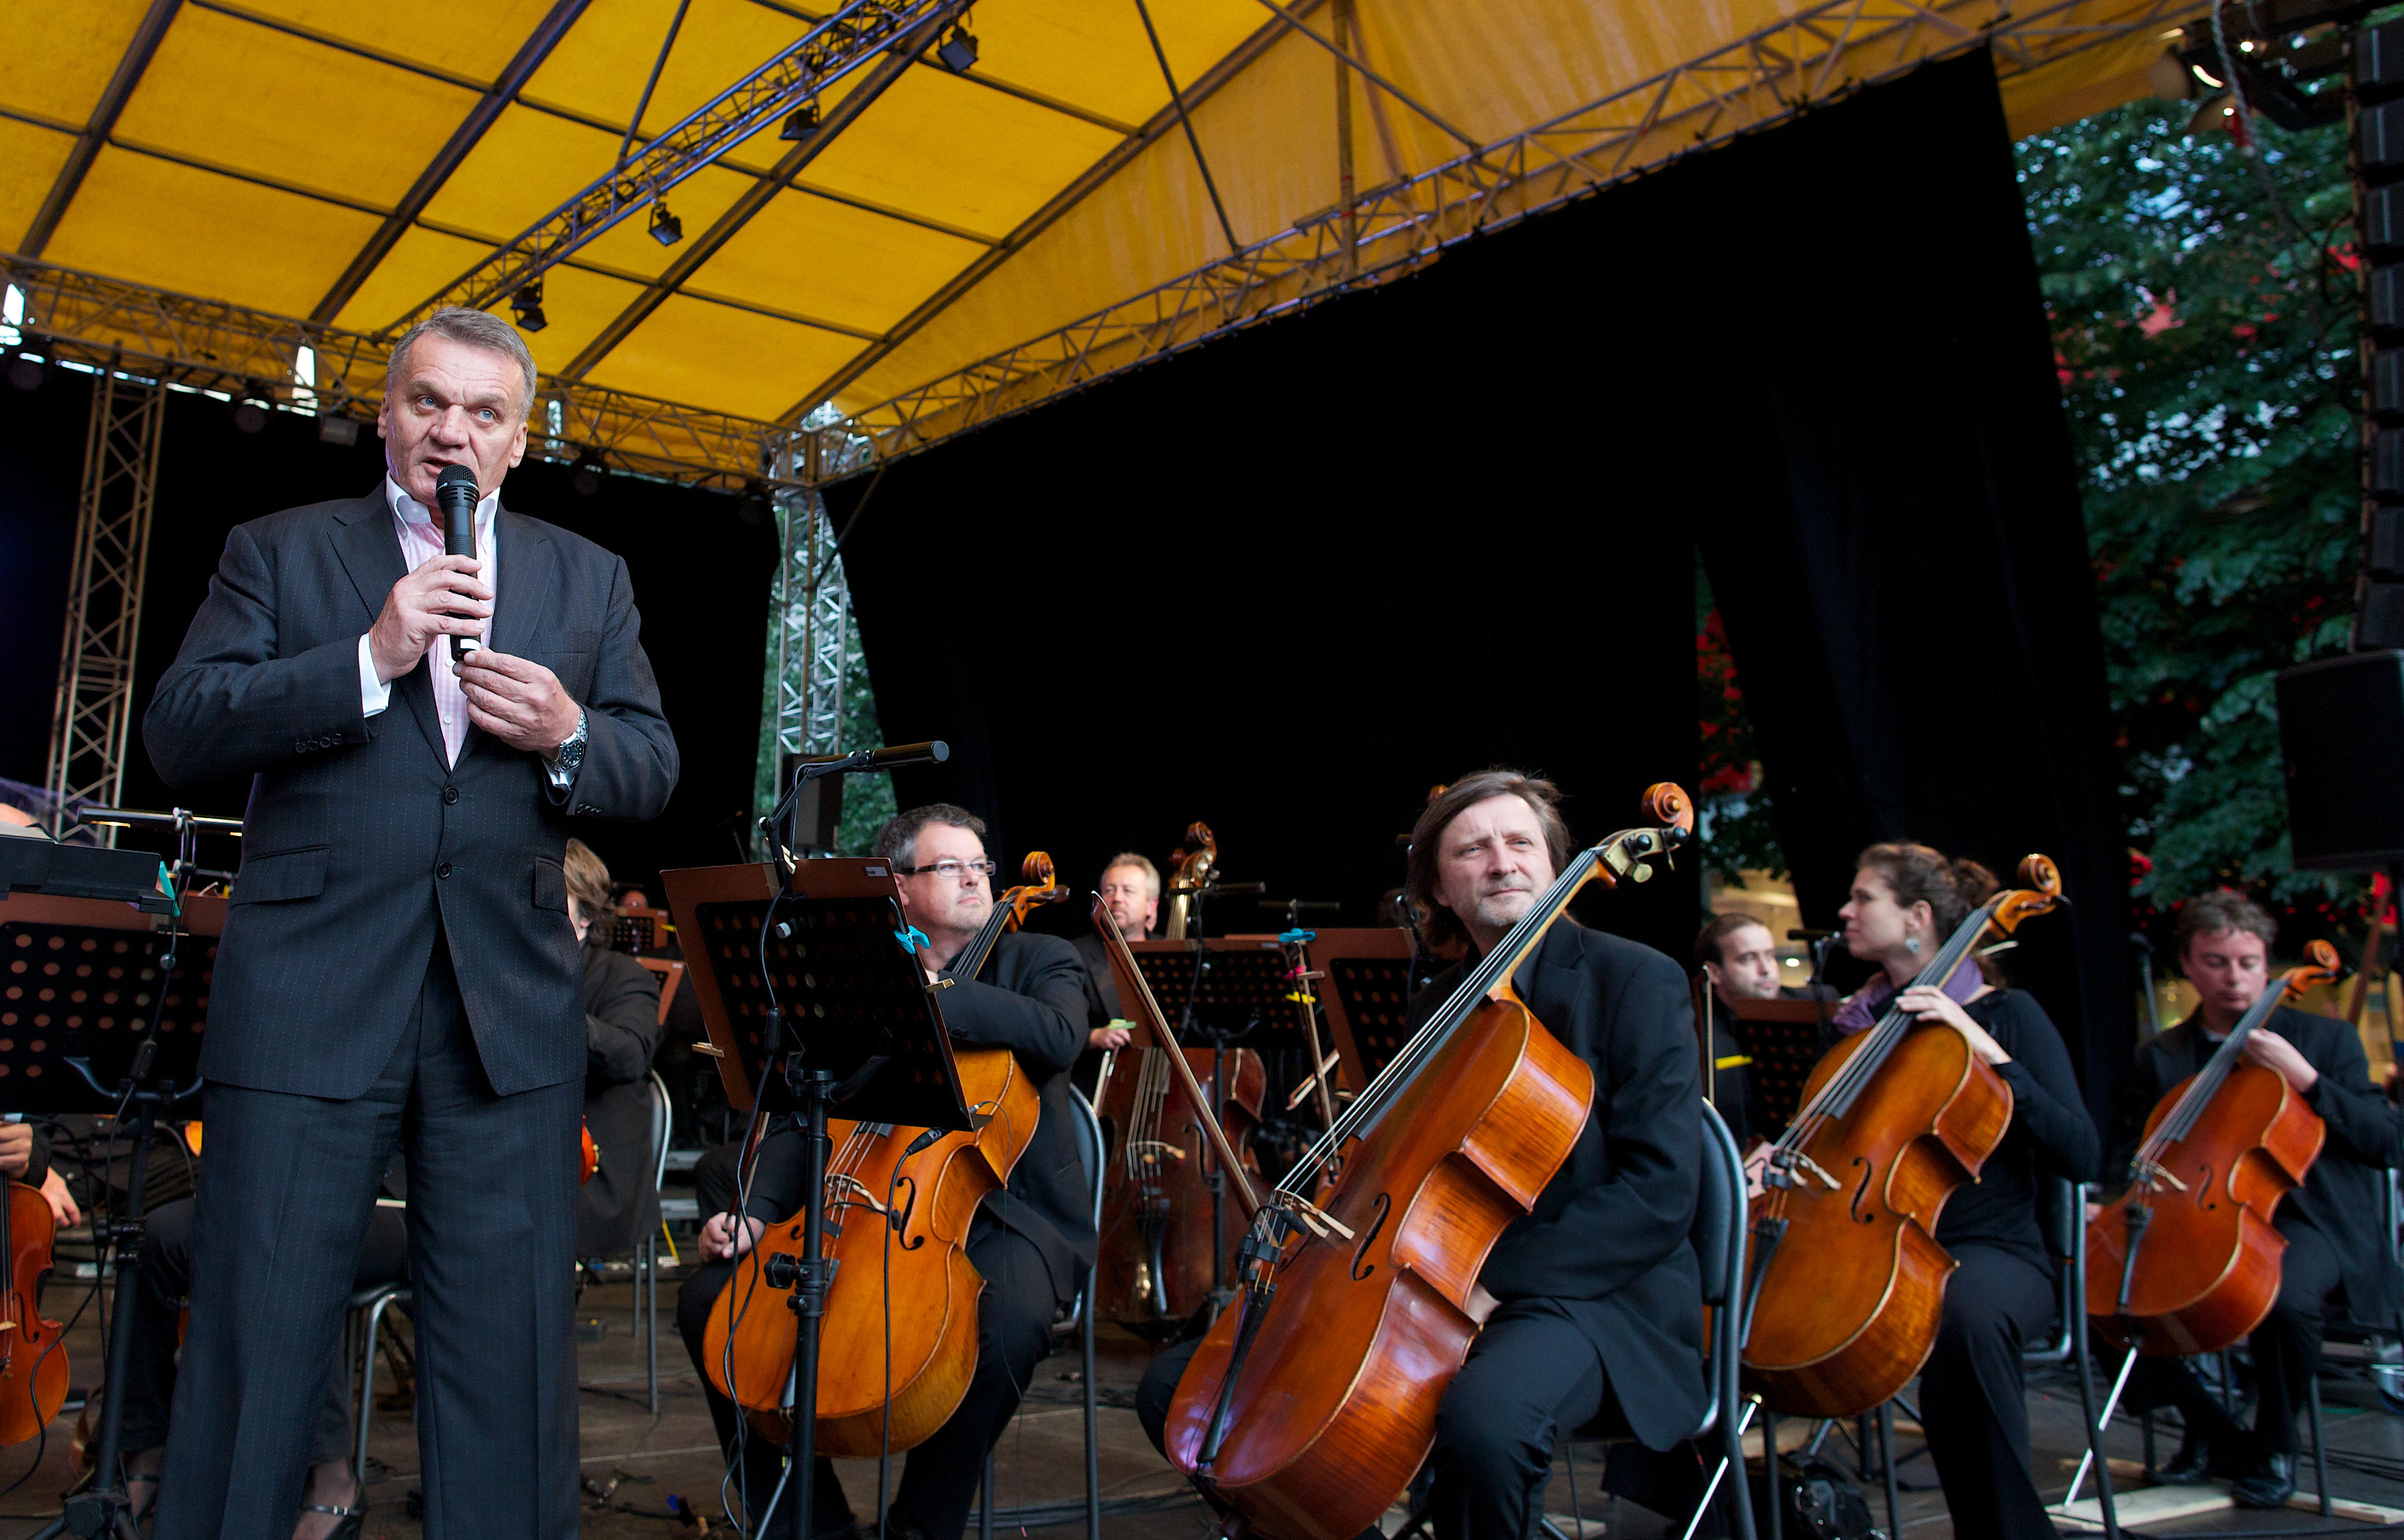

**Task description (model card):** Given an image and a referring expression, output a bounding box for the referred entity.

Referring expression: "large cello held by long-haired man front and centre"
[1166,783,1695,1540]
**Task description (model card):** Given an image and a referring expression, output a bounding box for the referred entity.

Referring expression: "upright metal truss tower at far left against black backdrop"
[43,373,166,845]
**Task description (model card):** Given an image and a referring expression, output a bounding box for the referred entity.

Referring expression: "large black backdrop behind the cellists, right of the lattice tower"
[829,53,2130,1112]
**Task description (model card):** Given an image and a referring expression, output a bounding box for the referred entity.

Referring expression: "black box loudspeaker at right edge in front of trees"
[2279,651,2404,870]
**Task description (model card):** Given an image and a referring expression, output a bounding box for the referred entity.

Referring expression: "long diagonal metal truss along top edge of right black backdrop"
[818,0,2207,459]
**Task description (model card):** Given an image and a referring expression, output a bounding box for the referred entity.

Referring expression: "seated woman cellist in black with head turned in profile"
[1837,843,2097,1540]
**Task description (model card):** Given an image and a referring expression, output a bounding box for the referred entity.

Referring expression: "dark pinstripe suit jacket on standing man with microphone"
[142,488,675,1100]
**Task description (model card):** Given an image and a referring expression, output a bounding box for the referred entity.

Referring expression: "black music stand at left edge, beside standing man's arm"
[0,889,211,1540]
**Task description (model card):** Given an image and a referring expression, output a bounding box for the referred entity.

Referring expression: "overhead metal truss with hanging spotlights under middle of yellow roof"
[394,0,966,332]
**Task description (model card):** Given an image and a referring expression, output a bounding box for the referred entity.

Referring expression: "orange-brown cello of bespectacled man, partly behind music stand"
[702,851,1067,1461]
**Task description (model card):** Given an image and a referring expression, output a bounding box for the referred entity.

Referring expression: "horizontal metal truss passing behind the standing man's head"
[0,255,786,488]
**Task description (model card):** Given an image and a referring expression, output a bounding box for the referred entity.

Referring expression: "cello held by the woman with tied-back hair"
[1745,855,2062,1418]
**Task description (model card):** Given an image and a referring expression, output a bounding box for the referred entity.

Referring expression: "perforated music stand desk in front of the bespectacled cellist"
[661,860,978,1129]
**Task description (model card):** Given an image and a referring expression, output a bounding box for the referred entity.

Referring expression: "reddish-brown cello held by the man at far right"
[2087,942,2339,1358]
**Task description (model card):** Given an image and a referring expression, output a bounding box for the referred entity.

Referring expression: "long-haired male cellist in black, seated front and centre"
[1135,769,1707,1540]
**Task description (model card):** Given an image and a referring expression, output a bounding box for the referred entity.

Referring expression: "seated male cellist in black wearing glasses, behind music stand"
[675,803,1094,1540]
